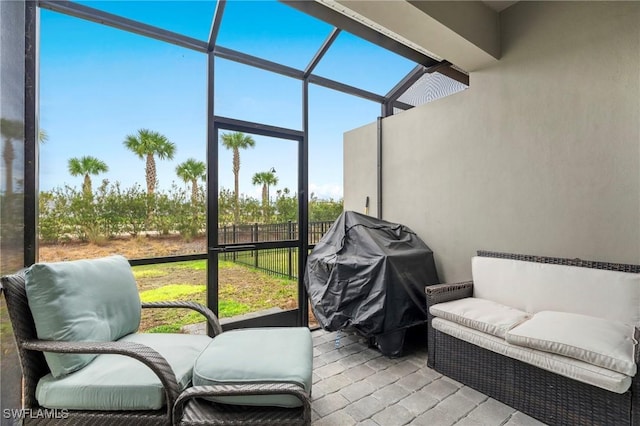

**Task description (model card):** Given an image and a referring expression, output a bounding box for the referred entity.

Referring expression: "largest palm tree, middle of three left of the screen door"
[123,129,176,194]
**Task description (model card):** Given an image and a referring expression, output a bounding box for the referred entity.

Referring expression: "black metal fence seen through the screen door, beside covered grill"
[218,221,333,279]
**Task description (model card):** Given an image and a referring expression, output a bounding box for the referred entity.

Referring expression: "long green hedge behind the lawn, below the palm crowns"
[39,180,342,243]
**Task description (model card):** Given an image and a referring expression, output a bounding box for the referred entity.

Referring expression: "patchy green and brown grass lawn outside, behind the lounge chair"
[133,260,297,333]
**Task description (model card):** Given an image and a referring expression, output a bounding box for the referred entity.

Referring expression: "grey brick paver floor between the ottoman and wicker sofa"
[311,330,543,426]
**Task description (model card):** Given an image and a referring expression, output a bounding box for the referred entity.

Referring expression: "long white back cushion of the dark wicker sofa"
[472,256,640,326]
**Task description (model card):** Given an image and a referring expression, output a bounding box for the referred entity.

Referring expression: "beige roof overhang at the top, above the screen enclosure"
[302,0,501,72]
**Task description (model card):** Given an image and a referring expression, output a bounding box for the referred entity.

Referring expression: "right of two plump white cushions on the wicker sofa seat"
[506,311,637,376]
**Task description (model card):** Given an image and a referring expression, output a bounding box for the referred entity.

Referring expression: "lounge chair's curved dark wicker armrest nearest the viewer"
[22,340,179,418]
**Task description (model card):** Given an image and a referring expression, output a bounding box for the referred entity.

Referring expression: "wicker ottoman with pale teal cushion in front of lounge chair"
[174,327,313,425]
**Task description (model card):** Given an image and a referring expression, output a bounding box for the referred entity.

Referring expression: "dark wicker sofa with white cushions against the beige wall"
[426,251,640,425]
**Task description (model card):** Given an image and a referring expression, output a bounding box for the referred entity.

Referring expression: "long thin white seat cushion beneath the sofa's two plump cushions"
[432,318,631,393]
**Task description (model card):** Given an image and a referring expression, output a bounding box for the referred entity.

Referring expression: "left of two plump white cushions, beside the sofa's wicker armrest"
[429,297,531,339]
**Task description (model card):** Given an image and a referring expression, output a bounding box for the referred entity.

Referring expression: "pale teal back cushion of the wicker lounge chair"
[25,256,140,378]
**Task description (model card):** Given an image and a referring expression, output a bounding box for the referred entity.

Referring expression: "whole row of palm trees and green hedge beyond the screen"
[39,129,342,243]
